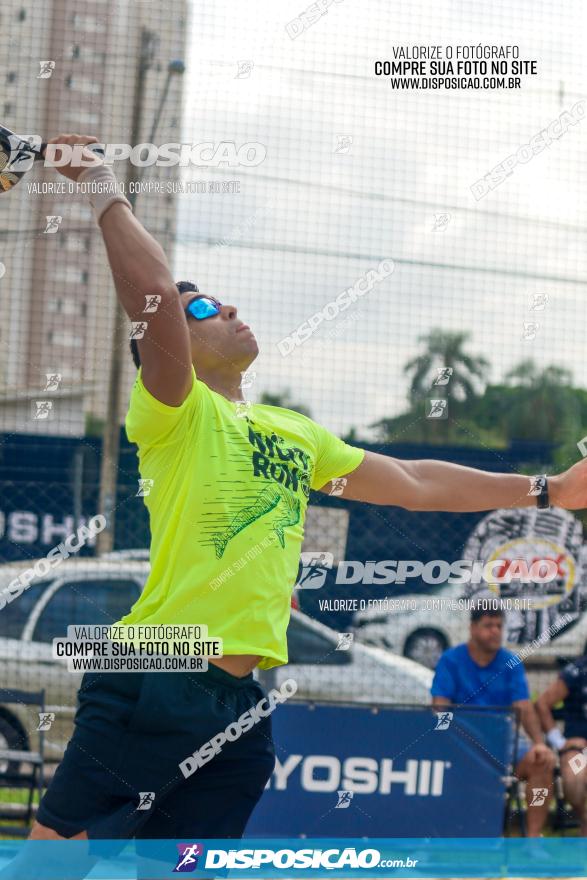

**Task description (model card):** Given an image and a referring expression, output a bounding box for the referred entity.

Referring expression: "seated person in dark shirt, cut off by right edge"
[536,654,587,837]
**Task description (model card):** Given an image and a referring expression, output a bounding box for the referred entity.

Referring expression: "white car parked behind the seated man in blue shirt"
[352,547,587,669]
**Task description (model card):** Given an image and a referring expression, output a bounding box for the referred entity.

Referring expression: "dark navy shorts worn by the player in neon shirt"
[37,664,275,840]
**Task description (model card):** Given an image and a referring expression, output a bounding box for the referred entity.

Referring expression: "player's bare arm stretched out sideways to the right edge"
[320,452,587,512]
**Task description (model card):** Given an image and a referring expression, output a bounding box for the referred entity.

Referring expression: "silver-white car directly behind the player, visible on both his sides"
[0,553,432,760]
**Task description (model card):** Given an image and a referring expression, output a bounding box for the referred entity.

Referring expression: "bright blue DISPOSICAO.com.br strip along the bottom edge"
[0,837,587,880]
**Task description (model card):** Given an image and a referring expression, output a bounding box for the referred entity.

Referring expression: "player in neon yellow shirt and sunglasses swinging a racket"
[31,134,587,840]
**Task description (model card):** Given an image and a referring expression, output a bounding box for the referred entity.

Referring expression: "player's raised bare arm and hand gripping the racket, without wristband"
[49,134,192,406]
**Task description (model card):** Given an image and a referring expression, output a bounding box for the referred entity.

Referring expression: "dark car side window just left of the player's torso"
[33,578,139,642]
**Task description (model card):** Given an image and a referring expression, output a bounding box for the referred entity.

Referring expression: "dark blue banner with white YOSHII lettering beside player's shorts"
[247,702,515,837]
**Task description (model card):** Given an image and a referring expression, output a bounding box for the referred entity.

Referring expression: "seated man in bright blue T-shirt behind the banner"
[432,601,556,837]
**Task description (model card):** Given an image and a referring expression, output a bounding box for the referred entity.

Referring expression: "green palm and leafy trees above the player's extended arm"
[371,329,587,467]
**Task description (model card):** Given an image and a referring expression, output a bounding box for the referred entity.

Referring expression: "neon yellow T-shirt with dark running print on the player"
[113,369,365,669]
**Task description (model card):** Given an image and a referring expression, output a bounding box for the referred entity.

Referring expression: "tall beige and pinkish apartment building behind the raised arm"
[0,0,188,436]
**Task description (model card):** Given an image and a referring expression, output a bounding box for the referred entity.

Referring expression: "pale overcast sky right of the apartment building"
[174,0,587,435]
